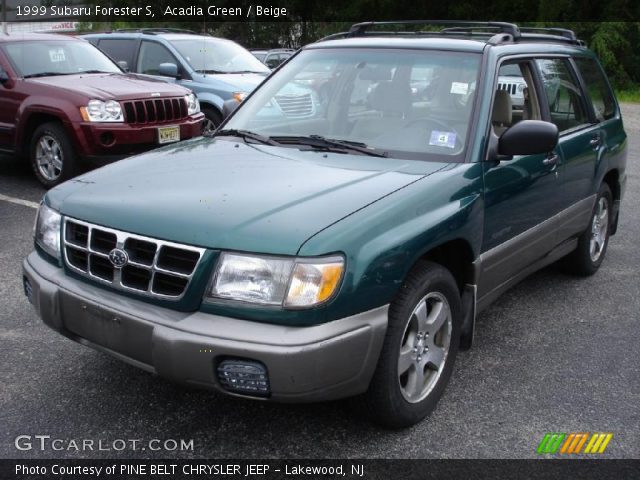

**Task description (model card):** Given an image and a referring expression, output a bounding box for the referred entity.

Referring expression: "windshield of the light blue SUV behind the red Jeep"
[171,37,270,73]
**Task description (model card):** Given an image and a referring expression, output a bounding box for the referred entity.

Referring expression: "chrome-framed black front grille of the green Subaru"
[63,218,204,300]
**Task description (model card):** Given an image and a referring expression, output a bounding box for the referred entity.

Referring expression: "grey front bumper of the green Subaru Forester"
[23,252,388,402]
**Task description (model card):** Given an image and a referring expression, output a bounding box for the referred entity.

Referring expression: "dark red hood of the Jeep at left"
[30,73,189,100]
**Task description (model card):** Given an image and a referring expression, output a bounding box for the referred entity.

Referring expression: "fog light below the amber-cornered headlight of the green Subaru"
[218,359,270,397]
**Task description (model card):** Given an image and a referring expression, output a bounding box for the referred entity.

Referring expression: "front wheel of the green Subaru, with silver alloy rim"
[364,262,462,428]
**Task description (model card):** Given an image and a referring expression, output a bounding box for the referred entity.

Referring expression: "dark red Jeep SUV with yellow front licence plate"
[0,34,203,187]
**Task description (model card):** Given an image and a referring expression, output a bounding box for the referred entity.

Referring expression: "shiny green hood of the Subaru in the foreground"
[46,139,446,255]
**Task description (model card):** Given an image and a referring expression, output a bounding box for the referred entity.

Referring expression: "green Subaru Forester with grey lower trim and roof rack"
[24,22,627,427]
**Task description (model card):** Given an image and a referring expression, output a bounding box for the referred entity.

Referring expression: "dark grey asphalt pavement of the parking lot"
[0,105,640,459]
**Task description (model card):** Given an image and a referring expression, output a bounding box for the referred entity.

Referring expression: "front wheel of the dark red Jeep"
[29,122,75,188]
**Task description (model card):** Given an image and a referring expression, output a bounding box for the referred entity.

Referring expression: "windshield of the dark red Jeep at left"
[4,39,121,78]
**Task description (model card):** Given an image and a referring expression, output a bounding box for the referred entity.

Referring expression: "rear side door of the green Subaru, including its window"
[536,57,602,243]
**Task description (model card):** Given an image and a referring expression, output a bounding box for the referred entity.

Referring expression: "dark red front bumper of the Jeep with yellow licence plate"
[71,112,204,158]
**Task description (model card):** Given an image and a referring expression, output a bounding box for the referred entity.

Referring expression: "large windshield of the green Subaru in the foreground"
[225,48,480,161]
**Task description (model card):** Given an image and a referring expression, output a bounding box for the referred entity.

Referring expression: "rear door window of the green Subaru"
[537,58,589,132]
